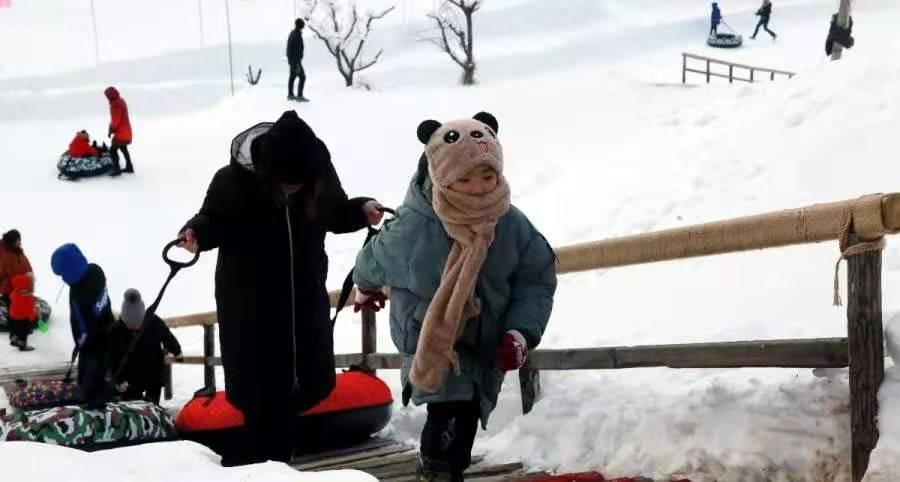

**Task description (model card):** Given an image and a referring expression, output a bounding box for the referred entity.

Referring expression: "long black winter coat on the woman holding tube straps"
[186,125,369,412]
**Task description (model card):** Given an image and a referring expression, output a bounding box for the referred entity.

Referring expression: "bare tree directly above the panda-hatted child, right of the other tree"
[424,0,484,85]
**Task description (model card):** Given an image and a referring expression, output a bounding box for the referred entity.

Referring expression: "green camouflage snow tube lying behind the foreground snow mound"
[0,401,177,448]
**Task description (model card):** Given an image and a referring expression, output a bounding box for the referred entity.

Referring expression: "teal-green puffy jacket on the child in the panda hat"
[353,168,556,426]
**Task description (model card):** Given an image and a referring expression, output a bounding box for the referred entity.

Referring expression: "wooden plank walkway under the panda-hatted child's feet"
[291,438,545,482]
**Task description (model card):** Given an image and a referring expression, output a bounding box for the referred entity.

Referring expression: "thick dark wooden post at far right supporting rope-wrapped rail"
[847,236,884,482]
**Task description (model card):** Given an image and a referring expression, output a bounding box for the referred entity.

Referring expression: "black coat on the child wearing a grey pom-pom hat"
[109,314,181,388]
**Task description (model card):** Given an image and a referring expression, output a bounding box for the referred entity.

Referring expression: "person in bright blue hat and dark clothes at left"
[50,243,115,407]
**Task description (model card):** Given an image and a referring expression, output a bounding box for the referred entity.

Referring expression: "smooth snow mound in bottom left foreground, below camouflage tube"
[0,442,377,482]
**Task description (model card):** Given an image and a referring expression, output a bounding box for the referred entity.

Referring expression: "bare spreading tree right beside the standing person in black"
[306,0,395,87]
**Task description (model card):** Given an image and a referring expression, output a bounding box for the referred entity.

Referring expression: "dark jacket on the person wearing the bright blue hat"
[69,263,115,357]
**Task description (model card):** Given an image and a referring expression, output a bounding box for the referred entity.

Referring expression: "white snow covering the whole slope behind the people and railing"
[0,0,900,481]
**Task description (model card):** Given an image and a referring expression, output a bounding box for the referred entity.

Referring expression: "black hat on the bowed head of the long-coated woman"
[250,110,331,184]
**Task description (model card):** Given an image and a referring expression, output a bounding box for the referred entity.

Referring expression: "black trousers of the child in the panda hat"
[420,396,481,480]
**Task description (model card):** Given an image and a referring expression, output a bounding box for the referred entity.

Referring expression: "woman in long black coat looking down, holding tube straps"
[180,111,381,466]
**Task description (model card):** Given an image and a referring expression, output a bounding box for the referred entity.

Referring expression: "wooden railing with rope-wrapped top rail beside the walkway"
[167,194,900,481]
